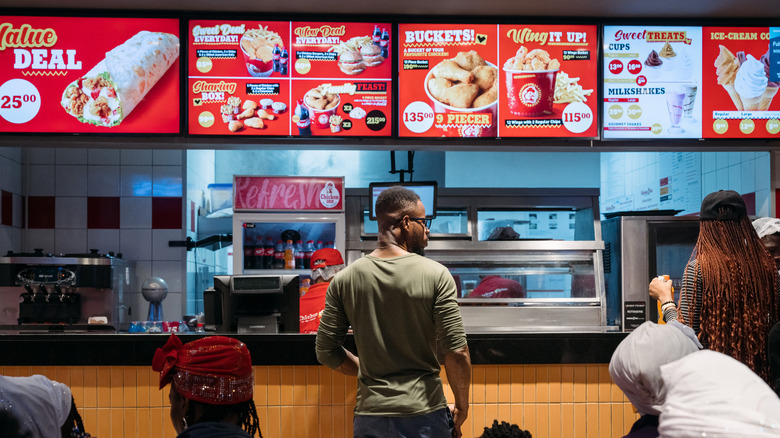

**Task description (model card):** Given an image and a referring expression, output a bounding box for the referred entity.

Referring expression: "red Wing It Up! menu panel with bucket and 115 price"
[498,24,599,137]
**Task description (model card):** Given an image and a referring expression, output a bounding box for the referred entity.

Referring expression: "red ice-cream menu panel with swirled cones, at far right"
[702,27,780,138]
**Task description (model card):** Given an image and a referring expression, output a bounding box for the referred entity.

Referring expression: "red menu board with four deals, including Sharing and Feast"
[187,20,392,137]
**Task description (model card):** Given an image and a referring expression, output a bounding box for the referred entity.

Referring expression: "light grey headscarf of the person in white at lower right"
[609,321,701,415]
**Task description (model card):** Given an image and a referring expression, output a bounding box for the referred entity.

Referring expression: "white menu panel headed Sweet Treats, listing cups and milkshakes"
[602,26,704,139]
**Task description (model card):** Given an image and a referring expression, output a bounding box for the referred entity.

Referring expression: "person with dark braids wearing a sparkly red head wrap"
[152,335,263,438]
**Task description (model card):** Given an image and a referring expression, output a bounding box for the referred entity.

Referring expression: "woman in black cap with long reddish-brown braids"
[650,190,780,382]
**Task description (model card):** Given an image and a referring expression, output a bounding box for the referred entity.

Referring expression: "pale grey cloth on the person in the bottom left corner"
[0,374,71,438]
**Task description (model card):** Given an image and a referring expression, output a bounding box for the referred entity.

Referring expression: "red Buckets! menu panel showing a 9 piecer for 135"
[398,24,500,137]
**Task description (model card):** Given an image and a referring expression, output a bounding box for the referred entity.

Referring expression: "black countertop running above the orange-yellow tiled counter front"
[0,332,627,366]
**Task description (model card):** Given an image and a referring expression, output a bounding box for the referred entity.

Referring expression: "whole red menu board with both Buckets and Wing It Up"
[398,24,599,137]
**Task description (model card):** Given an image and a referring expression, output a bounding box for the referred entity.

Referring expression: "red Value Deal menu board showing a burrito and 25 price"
[0,16,180,134]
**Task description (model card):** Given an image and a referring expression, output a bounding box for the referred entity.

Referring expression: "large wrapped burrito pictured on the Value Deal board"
[61,31,179,127]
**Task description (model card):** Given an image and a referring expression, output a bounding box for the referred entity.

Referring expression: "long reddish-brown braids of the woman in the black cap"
[683,212,778,382]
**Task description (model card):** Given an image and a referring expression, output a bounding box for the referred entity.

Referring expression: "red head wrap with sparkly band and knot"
[152,335,254,405]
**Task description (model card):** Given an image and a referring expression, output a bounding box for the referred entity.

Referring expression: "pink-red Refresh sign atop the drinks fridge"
[233,175,344,211]
